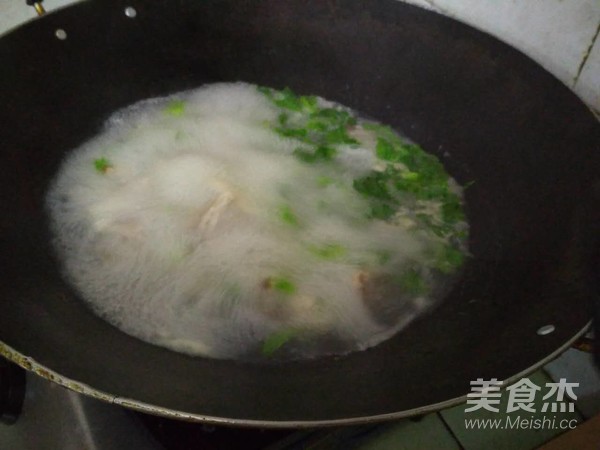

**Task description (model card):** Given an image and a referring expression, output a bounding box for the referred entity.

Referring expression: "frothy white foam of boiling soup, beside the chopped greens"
[48,83,464,358]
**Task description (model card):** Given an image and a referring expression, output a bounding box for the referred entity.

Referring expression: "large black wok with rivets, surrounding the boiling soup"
[0,0,600,426]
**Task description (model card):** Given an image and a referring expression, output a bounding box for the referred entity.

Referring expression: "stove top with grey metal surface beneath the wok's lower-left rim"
[0,358,293,450]
